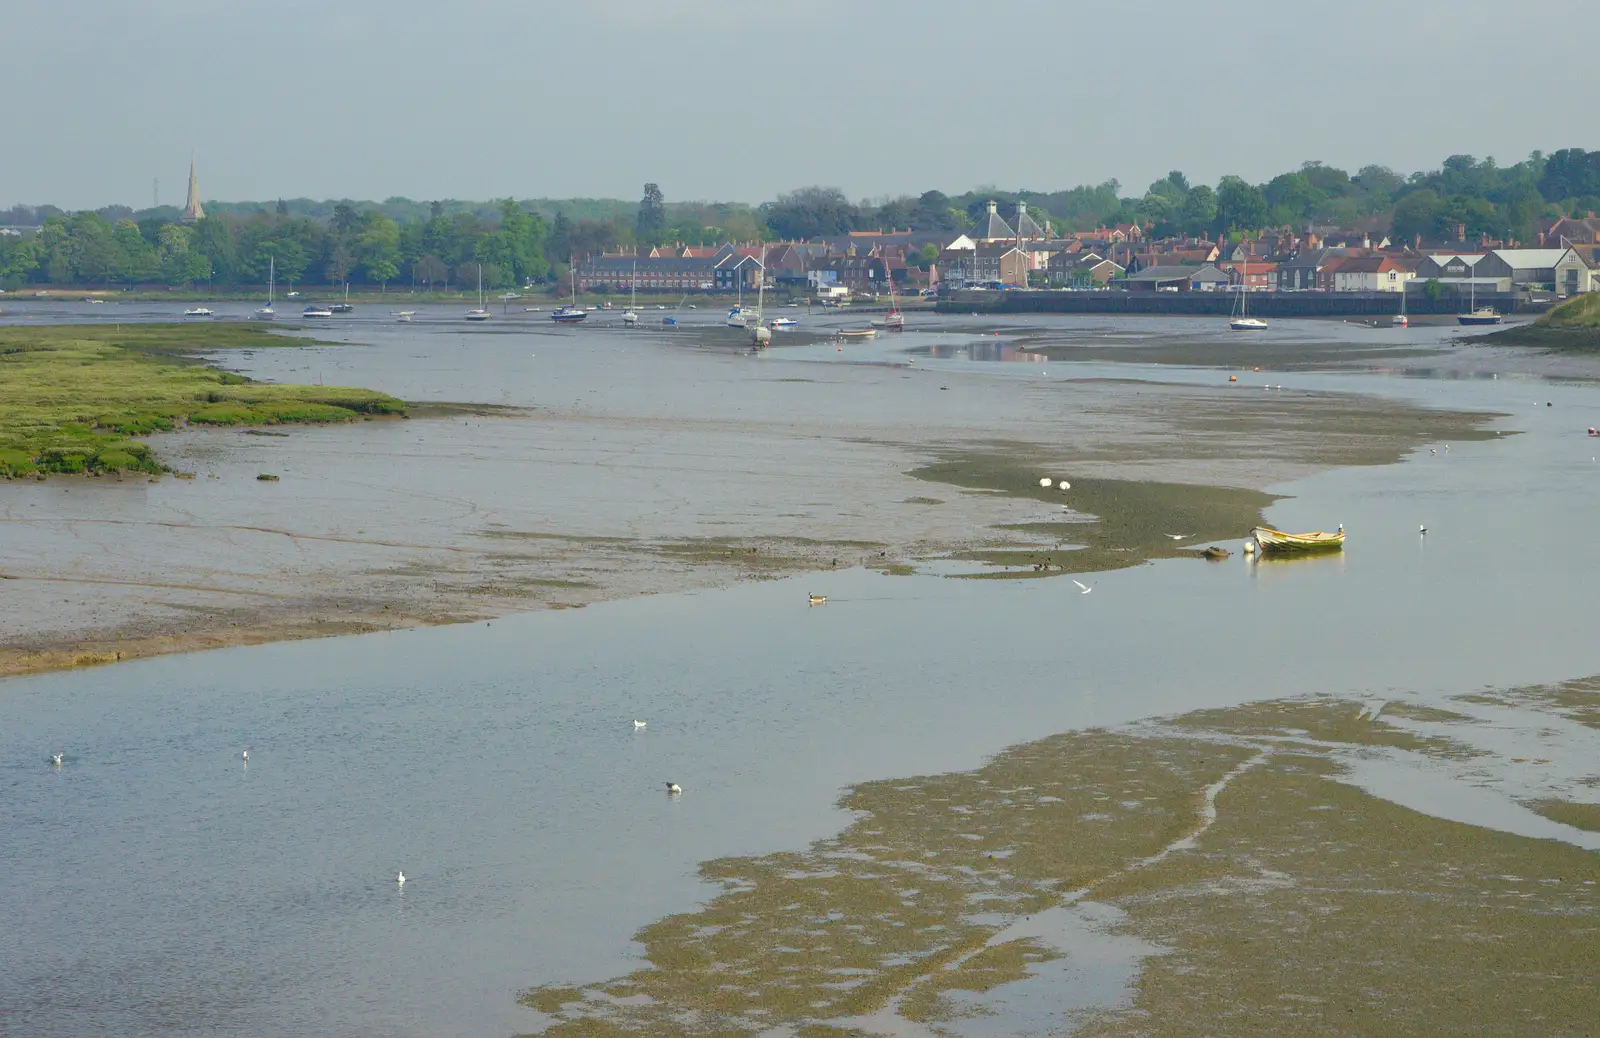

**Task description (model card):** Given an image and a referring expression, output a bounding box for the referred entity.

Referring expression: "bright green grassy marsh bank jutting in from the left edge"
[0,323,405,478]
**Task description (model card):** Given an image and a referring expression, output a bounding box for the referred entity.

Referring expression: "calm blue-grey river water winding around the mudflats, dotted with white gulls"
[0,304,1600,1035]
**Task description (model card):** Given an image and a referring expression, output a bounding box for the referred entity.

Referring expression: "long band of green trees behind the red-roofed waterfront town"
[0,149,1600,291]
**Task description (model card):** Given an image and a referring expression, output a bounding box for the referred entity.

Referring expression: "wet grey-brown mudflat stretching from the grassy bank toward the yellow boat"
[0,329,1490,675]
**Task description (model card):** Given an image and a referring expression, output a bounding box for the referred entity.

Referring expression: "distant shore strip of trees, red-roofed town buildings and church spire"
[0,149,1600,301]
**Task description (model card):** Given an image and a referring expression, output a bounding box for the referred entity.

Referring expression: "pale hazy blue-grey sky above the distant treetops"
[0,0,1600,208]
